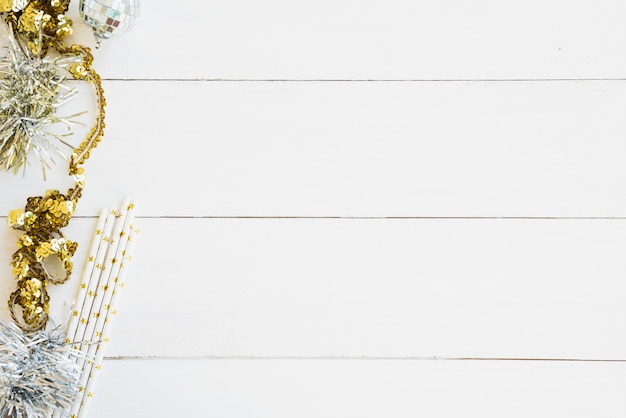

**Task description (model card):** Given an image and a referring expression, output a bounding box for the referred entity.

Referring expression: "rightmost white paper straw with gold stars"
[77,225,138,418]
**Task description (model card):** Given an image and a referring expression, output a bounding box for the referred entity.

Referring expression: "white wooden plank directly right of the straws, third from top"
[30,219,626,359]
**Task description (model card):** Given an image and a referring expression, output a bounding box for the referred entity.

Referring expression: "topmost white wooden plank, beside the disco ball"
[61,0,626,80]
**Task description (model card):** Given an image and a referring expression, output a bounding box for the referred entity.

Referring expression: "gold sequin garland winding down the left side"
[0,0,106,332]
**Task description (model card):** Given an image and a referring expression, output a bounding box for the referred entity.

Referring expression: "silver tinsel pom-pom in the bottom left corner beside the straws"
[0,323,81,418]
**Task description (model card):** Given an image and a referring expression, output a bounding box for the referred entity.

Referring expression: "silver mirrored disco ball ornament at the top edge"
[79,0,139,48]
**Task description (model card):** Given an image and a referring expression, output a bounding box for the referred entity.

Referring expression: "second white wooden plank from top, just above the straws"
[0,82,626,217]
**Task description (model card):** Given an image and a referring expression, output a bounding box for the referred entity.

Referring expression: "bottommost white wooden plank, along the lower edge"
[91,360,626,418]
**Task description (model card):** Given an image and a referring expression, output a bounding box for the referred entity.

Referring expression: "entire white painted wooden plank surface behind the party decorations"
[0,0,626,418]
